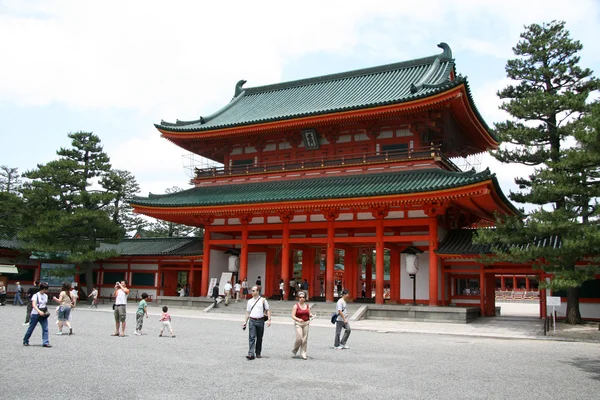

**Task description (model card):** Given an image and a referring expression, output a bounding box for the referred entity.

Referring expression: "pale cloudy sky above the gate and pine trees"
[0,0,600,211]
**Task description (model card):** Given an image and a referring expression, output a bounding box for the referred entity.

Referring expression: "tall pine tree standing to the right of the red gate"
[476,21,600,323]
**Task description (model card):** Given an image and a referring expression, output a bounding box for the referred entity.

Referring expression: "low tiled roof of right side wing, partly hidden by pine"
[436,229,561,255]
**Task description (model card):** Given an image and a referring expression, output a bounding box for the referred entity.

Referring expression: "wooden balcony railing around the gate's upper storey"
[195,145,459,179]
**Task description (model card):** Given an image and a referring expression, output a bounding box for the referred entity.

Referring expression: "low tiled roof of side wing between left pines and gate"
[98,237,203,256]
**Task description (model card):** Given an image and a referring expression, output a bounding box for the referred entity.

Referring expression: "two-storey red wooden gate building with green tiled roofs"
[132,43,517,309]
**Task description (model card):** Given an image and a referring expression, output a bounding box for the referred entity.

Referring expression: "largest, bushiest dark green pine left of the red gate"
[19,132,124,265]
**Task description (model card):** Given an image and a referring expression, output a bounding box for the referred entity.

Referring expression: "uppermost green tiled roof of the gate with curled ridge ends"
[155,43,485,132]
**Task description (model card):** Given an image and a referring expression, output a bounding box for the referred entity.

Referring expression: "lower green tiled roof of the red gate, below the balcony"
[131,169,502,207]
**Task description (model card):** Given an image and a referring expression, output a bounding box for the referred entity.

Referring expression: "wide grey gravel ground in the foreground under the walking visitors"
[0,304,600,400]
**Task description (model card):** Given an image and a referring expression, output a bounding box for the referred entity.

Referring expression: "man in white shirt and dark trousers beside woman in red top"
[242,286,271,360]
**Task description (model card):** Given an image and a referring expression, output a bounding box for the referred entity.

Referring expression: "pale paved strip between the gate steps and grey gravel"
[143,301,600,343]
